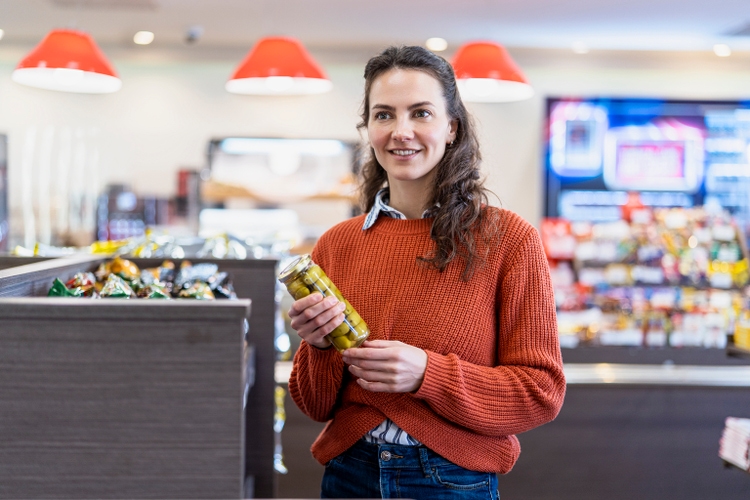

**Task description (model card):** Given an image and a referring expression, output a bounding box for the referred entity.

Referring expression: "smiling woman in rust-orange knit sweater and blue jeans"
[289,47,565,498]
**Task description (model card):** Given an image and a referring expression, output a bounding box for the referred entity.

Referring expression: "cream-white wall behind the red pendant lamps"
[0,45,750,246]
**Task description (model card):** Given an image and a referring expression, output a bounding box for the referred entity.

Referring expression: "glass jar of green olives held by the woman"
[279,254,370,352]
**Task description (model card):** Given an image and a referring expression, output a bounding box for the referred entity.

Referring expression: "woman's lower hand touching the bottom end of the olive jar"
[343,340,427,392]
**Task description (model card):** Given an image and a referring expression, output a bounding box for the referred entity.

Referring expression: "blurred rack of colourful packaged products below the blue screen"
[542,209,748,349]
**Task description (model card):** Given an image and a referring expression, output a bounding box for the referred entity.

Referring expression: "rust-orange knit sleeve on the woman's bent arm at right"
[415,228,565,436]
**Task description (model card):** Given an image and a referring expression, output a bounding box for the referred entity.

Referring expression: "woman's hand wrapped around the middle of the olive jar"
[289,292,346,349]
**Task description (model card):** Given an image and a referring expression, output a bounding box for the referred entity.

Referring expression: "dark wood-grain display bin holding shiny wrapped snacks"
[0,255,277,498]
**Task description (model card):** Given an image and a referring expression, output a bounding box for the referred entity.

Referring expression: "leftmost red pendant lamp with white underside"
[12,29,122,94]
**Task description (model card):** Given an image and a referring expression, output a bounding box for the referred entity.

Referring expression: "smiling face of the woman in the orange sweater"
[367,69,458,185]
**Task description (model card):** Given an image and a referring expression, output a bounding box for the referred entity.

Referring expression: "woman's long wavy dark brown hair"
[357,46,497,281]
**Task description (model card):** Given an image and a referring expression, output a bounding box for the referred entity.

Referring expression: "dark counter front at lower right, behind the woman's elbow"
[500,385,750,500]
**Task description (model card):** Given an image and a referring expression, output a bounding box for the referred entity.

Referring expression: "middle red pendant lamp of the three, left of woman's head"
[226,37,333,95]
